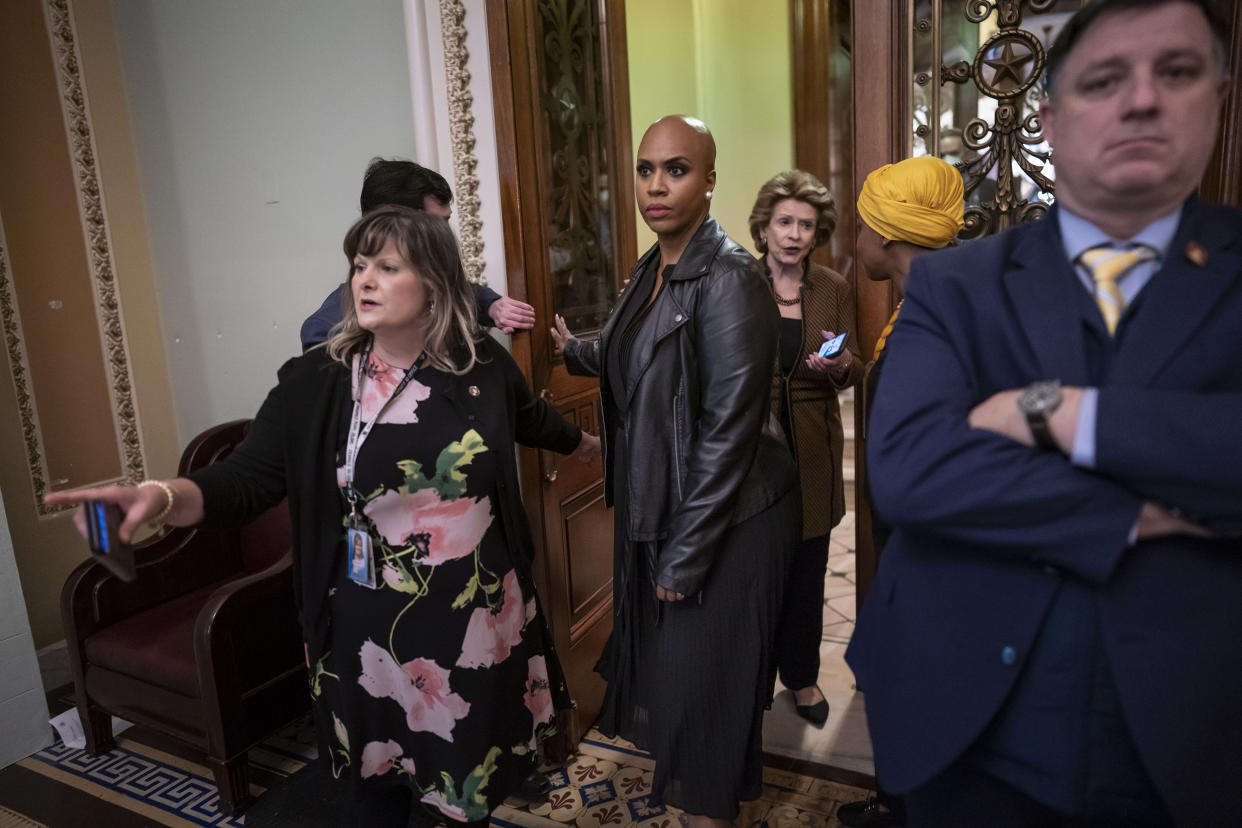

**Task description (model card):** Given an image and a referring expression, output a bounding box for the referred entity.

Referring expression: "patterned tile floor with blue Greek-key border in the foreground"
[7,705,867,828]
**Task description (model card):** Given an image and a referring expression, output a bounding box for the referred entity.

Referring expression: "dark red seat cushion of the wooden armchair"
[86,581,227,699]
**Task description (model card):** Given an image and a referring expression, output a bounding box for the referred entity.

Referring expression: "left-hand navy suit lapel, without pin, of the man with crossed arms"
[1004,217,1087,385]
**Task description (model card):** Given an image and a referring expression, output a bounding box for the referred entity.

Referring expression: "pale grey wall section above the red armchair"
[113,0,422,446]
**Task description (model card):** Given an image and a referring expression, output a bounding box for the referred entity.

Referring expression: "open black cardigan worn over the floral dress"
[190,336,581,664]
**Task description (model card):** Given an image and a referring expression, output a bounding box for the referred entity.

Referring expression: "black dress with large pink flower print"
[311,354,553,822]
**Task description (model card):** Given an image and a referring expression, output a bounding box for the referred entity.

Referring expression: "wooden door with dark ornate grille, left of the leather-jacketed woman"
[487,0,636,747]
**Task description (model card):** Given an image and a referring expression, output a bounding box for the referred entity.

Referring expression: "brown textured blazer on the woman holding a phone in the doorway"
[771,263,863,540]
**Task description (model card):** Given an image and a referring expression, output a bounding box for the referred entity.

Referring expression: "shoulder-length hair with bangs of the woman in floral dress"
[324,205,482,374]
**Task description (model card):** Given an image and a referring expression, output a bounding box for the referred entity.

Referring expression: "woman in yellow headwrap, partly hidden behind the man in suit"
[837,156,964,828]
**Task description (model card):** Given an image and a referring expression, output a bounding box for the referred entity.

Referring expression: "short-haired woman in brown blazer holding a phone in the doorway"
[750,170,863,726]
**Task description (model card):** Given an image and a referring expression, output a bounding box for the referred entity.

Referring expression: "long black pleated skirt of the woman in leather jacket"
[596,487,801,819]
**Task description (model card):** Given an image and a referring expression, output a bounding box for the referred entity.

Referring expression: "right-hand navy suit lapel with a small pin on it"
[1112,204,1242,386]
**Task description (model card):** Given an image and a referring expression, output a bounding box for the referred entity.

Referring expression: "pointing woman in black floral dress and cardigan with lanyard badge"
[48,207,599,826]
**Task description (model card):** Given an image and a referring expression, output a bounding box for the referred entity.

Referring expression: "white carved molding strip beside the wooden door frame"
[440,0,487,284]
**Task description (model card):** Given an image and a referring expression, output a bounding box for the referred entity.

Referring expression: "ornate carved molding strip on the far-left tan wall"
[37,0,147,515]
